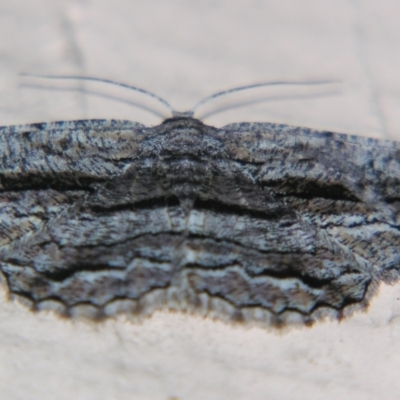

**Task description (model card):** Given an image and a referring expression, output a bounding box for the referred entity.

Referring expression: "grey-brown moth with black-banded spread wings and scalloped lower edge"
[0,76,400,326]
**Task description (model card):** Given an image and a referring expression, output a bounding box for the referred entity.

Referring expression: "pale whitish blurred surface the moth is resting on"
[0,0,400,400]
